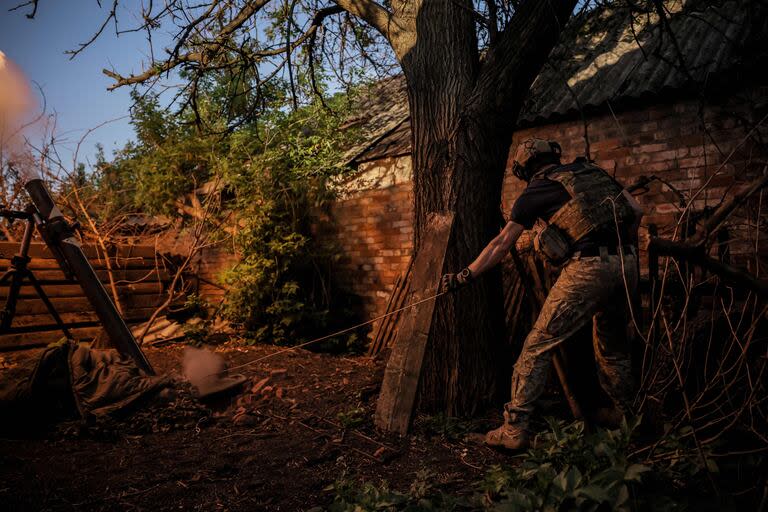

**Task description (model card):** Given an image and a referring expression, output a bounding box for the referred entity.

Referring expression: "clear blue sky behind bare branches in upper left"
[0,0,170,162]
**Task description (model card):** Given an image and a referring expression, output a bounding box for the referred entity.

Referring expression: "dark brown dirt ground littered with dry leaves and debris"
[0,344,505,511]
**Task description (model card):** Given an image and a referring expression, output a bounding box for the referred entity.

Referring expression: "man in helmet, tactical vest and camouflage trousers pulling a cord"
[441,139,642,450]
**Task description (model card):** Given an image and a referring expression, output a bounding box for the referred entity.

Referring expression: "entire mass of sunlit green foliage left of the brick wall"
[103,81,362,350]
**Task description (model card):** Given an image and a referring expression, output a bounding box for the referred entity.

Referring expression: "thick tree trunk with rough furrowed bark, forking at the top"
[401,0,575,415]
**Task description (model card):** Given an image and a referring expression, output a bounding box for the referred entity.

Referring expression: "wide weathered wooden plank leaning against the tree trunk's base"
[374,212,453,434]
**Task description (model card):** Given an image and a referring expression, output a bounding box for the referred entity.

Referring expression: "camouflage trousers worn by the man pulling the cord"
[504,253,638,428]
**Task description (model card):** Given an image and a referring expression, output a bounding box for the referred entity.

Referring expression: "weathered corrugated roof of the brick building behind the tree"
[348,0,768,162]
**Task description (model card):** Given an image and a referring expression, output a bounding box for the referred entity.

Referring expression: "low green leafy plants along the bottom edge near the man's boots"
[320,420,699,512]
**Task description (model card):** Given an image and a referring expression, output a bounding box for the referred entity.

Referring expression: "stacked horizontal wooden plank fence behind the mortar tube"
[0,242,171,350]
